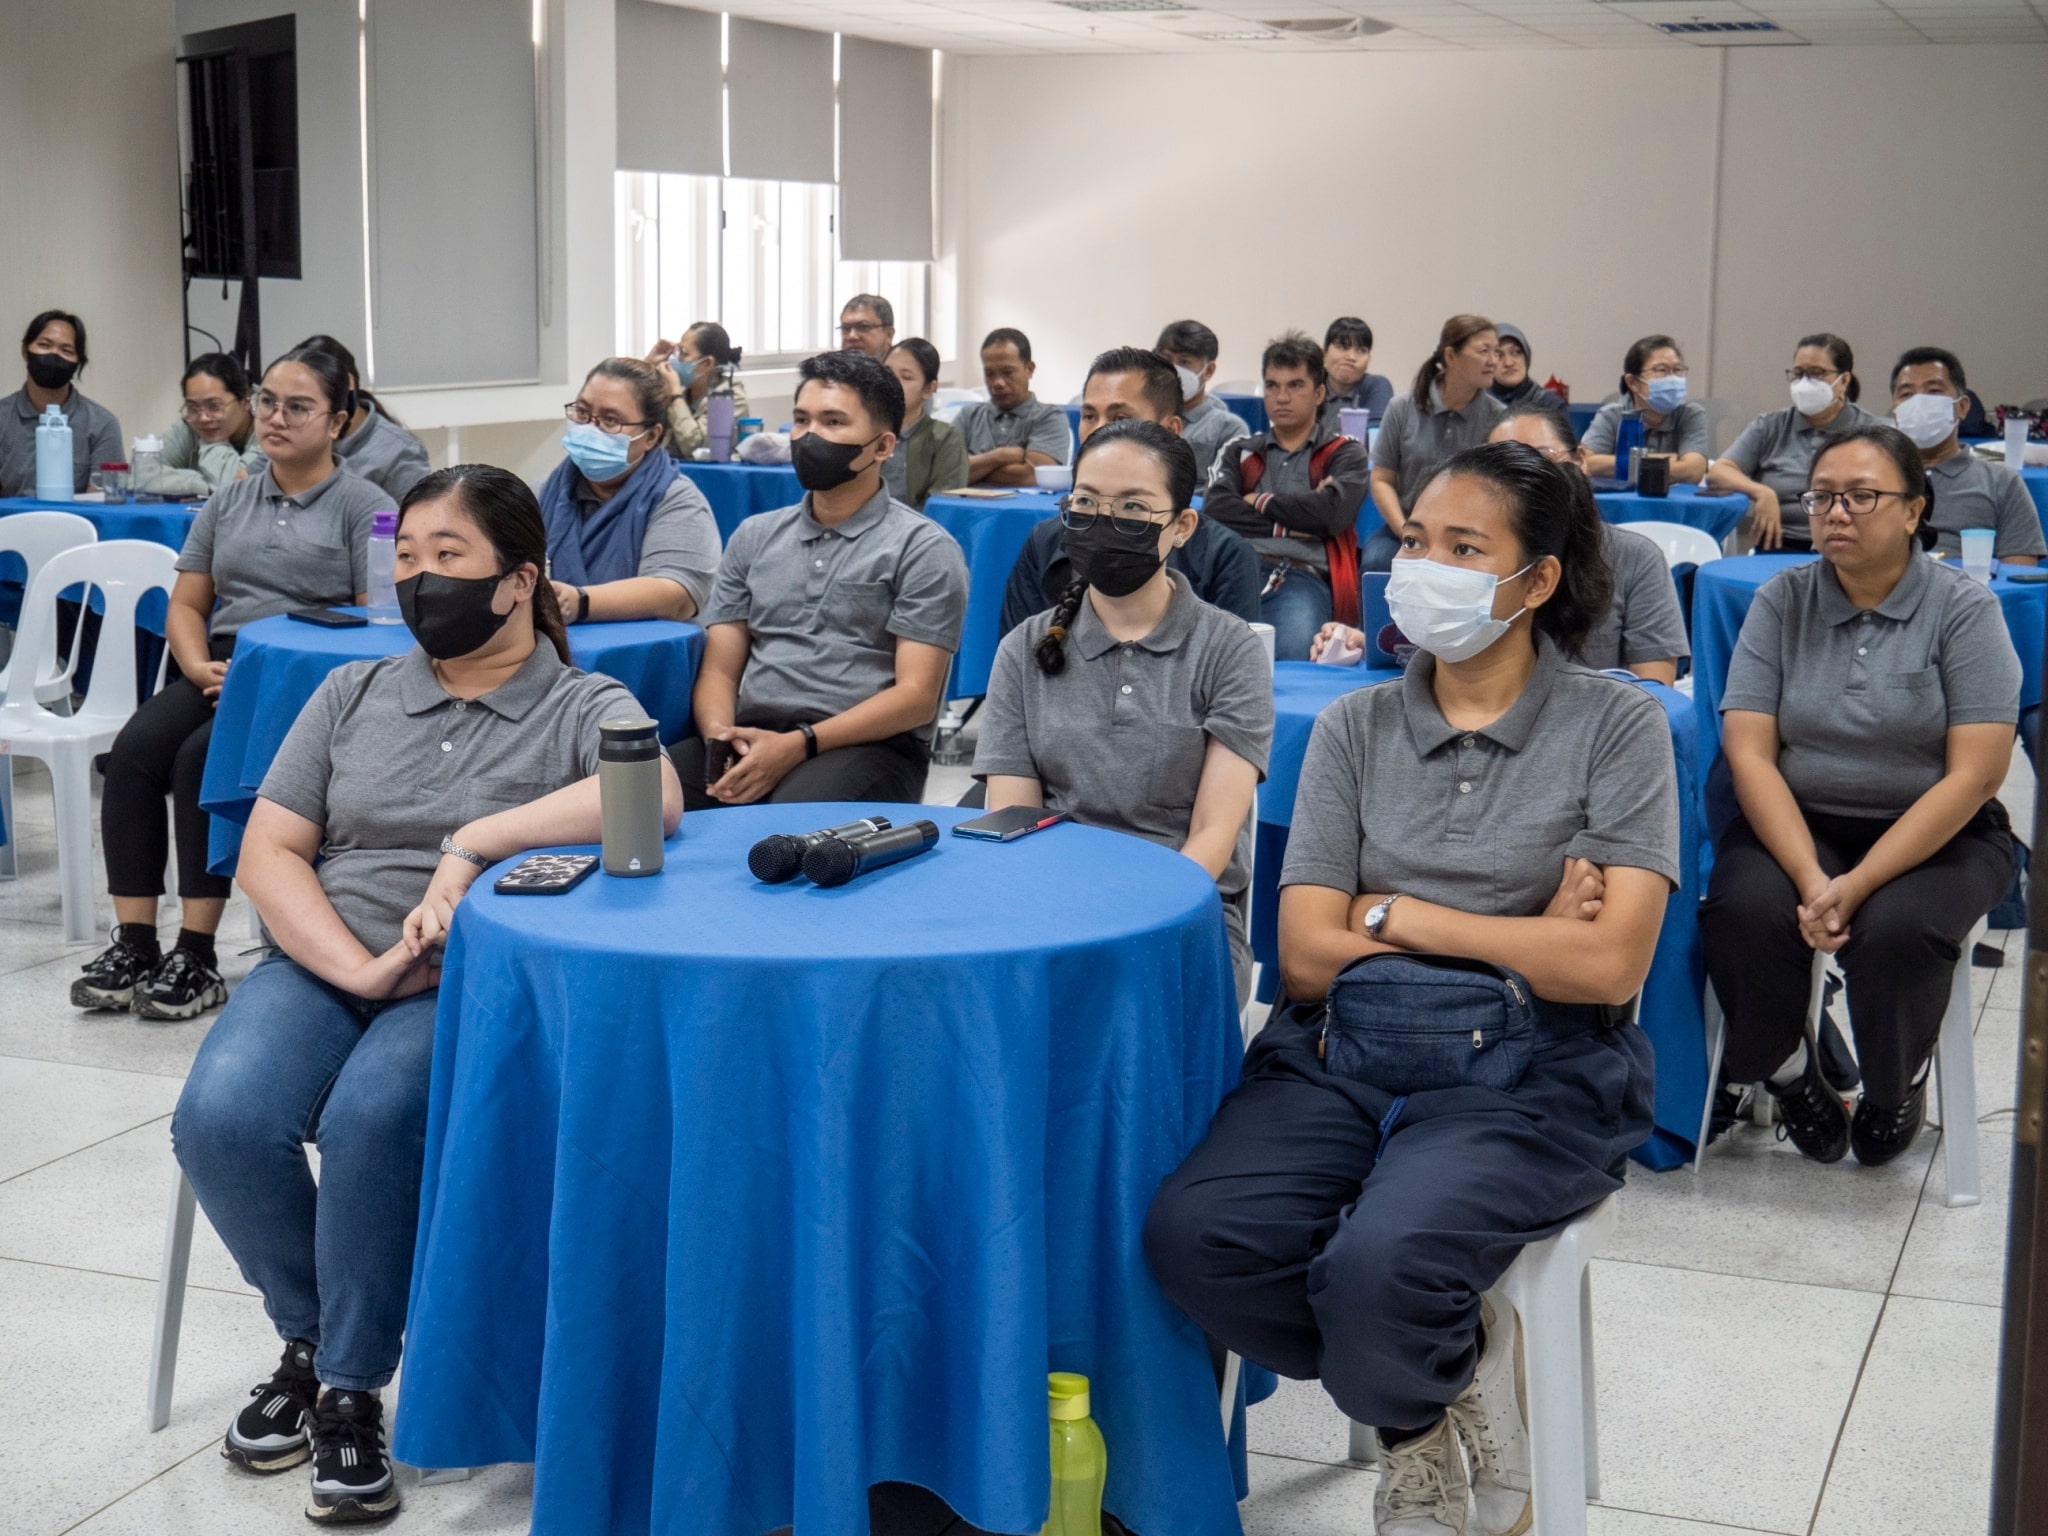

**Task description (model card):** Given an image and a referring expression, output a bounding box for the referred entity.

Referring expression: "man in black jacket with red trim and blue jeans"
[1202,332,1372,662]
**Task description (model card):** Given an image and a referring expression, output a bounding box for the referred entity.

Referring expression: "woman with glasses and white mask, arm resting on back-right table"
[1706,332,1882,549]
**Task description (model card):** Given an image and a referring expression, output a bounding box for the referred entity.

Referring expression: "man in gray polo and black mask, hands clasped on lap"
[674,350,967,809]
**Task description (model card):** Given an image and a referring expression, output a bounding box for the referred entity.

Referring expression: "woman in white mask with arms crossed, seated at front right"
[1145,442,1679,1536]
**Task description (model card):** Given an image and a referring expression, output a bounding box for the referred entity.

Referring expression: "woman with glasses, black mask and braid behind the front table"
[975,418,1274,1008]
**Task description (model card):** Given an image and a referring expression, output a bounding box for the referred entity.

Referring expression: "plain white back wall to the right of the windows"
[942,47,2048,430]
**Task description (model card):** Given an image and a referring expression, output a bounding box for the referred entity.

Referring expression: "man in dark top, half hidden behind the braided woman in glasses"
[1004,346,1260,635]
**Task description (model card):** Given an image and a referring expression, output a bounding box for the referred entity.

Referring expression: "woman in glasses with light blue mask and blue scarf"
[541,356,719,625]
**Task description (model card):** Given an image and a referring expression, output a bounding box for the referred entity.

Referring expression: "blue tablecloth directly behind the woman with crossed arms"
[1251,655,1714,1169]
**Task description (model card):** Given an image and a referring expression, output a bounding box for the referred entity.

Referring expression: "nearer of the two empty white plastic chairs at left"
[0,539,178,944]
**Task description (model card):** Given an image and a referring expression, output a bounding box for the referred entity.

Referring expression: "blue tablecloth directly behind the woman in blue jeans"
[199,614,705,874]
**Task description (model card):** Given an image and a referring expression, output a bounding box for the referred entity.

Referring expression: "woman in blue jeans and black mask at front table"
[170,465,682,1522]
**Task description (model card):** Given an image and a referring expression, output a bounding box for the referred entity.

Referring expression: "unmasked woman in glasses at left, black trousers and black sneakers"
[72,348,393,1020]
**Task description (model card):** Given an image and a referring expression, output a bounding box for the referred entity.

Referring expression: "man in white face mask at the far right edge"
[1892,346,2048,565]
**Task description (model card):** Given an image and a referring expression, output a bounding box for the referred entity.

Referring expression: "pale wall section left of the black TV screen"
[0,0,184,448]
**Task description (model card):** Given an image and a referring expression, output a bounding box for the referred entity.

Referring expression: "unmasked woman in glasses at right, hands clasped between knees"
[1700,426,2019,1165]
